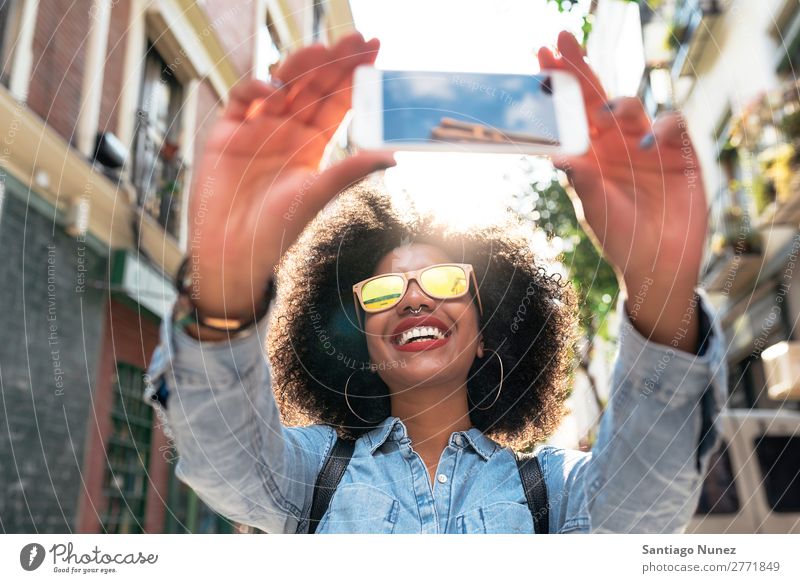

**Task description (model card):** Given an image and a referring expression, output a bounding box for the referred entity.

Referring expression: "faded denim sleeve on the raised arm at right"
[539,291,727,533]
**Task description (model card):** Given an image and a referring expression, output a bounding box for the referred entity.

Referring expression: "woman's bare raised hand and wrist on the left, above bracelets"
[182,33,394,319]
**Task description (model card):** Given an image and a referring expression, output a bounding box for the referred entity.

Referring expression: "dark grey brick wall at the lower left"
[0,182,105,533]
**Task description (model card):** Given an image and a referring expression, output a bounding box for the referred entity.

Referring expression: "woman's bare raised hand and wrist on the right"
[539,32,707,352]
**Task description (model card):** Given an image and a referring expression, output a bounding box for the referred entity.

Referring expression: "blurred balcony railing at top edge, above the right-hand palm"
[672,0,722,77]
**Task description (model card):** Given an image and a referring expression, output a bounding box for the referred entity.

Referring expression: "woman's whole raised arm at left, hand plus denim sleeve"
[143,34,394,532]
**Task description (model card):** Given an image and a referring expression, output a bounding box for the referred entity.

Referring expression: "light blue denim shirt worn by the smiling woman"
[145,290,727,533]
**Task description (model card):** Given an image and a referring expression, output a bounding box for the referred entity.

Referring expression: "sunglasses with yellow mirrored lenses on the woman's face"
[353,263,483,324]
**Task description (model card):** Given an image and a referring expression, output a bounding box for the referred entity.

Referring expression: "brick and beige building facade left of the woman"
[0,0,352,533]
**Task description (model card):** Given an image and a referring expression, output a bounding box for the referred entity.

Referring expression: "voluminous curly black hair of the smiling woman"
[267,182,577,449]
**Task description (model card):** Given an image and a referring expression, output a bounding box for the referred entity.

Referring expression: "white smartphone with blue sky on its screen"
[350,66,589,155]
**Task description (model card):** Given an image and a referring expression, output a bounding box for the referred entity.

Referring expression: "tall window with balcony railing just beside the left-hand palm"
[133,44,184,237]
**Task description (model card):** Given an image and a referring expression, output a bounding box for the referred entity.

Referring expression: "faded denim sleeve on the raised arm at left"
[147,322,336,533]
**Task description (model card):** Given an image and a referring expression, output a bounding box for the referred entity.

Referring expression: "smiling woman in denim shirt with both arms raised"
[144,33,726,533]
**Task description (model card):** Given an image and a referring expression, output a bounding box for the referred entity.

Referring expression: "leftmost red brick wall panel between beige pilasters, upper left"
[28,0,91,143]
